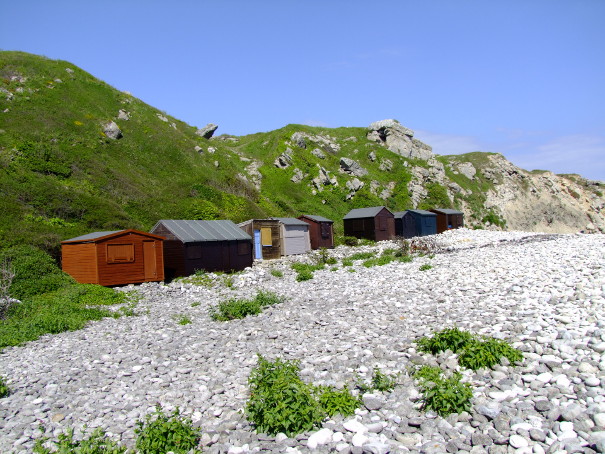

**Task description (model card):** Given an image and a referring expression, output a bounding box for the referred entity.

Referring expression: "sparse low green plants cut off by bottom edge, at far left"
[33,428,126,454]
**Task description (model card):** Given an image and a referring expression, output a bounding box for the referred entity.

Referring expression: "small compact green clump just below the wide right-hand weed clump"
[414,366,473,417]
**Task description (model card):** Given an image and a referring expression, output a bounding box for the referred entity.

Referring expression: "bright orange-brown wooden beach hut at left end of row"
[61,230,164,286]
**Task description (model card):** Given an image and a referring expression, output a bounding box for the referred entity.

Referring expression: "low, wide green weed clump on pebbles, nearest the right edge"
[416,327,523,370]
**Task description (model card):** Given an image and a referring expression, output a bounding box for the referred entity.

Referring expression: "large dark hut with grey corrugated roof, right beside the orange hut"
[151,219,252,279]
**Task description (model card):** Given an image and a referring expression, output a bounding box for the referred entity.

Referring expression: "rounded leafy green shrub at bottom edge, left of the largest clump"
[134,405,201,454]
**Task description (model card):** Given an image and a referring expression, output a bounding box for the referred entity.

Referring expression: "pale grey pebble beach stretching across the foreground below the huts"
[0,229,605,454]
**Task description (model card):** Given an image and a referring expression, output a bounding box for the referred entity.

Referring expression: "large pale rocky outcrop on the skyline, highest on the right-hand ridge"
[367,120,433,160]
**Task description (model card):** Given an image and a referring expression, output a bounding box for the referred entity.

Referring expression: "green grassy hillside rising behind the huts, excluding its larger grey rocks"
[0,52,422,256]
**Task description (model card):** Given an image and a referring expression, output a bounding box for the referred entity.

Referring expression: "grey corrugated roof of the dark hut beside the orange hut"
[153,219,252,243]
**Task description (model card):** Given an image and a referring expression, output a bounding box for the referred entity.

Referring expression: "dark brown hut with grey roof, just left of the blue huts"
[343,207,395,241]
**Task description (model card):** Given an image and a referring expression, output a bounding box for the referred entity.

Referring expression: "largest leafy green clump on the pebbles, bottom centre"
[245,355,360,436]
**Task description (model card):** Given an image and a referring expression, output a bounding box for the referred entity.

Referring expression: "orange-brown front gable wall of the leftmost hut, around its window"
[96,233,164,286]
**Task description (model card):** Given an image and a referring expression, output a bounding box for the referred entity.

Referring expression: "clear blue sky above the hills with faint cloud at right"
[0,0,605,180]
